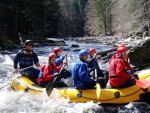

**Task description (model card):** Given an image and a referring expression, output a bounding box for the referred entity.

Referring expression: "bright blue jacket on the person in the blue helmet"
[71,60,93,88]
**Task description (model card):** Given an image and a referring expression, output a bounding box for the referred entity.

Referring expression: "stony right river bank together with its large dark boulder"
[67,36,150,69]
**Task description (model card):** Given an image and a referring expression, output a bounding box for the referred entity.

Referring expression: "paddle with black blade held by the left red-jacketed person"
[46,65,65,96]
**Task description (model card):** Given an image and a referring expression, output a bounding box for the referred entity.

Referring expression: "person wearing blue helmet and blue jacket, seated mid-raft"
[71,50,104,89]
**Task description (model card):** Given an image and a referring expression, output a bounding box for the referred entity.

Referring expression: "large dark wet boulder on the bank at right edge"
[128,37,150,67]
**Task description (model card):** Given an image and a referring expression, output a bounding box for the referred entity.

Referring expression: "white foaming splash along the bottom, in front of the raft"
[0,89,99,113]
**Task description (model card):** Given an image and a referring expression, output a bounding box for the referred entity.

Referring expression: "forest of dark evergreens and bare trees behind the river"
[0,0,150,45]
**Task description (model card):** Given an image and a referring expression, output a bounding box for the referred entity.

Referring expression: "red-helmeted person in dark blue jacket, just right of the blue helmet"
[87,48,108,87]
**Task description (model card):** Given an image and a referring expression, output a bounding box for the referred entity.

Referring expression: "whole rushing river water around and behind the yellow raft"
[0,41,150,113]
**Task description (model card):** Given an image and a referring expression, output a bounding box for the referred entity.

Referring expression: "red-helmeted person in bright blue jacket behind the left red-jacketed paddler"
[53,47,71,79]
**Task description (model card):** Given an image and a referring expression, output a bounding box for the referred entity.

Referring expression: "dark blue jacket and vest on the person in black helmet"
[14,50,39,69]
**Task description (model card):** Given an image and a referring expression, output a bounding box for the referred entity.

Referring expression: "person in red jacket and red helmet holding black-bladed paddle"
[37,53,67,87]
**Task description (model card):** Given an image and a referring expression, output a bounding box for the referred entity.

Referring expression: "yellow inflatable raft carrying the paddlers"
[11,70,150,104]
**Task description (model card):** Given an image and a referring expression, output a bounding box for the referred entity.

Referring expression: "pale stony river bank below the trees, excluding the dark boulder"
[65,35,145,47]
